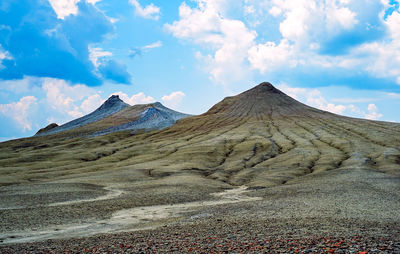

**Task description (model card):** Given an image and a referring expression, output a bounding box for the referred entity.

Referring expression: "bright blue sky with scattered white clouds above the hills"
[0,0,400,141]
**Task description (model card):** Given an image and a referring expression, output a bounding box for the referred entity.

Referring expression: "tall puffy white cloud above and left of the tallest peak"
[165,0,256,84]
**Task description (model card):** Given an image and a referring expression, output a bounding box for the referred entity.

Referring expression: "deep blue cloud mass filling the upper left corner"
[0,0,127,86]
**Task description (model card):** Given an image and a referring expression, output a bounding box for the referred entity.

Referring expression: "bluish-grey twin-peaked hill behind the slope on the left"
[36,95,190,137]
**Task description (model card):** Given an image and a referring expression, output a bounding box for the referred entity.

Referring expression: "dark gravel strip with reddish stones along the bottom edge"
[0,218,400,254]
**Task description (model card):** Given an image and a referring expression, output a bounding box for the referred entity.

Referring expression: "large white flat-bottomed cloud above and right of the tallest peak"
[244,0,360,73]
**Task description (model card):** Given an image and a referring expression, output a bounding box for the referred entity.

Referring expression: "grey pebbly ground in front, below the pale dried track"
[0,170,400,253]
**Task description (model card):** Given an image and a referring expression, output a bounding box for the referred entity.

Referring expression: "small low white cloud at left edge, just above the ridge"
[0,96,37,132]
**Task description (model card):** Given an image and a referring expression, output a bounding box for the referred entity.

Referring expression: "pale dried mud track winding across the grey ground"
[0,186,261,244]
